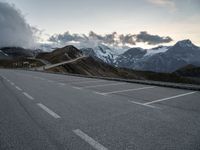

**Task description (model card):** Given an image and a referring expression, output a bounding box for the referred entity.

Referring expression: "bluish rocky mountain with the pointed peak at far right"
[133,40,200,72]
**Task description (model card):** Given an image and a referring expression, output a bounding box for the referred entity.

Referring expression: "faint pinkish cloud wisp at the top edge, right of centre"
[147,0,176,11]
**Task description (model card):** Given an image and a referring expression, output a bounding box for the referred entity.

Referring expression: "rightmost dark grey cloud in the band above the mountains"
[135,31,173,45]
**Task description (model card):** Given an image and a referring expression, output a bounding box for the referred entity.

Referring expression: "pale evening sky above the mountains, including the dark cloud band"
[0,0,200,47]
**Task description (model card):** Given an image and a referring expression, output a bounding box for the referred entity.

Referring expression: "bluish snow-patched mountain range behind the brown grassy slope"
[82,40,200,72]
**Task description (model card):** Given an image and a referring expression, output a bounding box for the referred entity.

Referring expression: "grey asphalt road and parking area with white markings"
[0,69,200,150]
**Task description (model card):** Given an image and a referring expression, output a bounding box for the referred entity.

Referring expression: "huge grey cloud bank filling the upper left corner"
[0,2,35,48]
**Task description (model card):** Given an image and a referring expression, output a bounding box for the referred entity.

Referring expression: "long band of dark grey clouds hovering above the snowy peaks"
[49,31,172,47]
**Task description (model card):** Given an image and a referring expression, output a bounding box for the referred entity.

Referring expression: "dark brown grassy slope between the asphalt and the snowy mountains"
[48,57,199,84]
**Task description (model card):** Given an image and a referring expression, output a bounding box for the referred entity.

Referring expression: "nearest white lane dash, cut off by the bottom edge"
[73,129,108,150]
